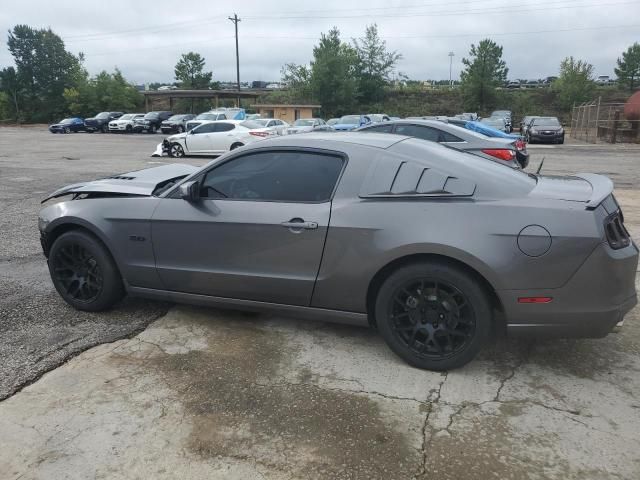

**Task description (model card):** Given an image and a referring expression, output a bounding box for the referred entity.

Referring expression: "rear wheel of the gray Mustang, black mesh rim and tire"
[374,261,492,371]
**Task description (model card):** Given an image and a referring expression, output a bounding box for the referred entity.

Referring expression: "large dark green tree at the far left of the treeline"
[7,25,83,122]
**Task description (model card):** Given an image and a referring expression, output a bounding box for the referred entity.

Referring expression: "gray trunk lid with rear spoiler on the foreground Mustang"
[529,173,613,208]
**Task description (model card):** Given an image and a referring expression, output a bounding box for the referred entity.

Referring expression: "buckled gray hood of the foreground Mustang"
[41,163,198,203]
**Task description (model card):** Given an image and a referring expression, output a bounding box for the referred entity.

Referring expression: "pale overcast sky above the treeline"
[0,0,640,83]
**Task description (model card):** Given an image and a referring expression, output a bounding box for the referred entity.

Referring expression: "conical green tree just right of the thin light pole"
[460,38,509,110]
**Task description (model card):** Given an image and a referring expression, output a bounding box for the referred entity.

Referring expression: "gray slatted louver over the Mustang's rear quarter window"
[360,159,476,198]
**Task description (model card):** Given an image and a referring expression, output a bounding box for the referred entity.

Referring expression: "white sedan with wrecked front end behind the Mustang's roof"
[153,120,276,158]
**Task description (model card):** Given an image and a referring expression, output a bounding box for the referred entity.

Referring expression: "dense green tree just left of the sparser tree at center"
[311,27,358,116]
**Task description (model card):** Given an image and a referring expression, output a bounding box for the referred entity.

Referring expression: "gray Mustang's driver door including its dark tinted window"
[152,150,345,306]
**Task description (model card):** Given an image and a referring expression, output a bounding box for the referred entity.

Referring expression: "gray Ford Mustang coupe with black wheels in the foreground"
[39,132,638,370]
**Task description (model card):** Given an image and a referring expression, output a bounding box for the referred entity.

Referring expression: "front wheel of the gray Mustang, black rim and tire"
[47,230,124,312]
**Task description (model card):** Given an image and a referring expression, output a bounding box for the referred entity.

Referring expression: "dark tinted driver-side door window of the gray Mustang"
[202,152,343,202]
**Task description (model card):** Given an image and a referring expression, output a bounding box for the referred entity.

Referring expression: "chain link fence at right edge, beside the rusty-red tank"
[569,98,640,143]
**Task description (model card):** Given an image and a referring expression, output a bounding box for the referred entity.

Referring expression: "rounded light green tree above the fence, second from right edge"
[552,57,595,110]
